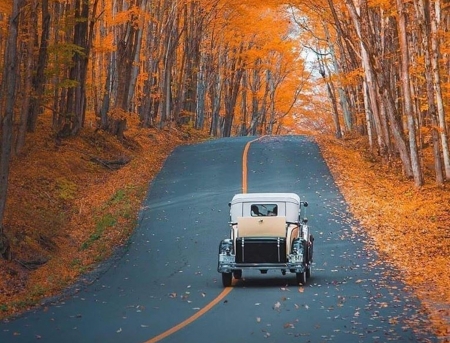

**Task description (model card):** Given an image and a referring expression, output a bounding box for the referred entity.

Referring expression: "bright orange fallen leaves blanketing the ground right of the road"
[316,137,450,340]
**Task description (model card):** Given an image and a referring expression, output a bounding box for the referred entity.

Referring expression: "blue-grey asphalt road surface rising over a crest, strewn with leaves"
[0,136,437,343]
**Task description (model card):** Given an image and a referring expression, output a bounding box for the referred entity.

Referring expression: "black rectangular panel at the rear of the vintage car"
[236,237,286,263]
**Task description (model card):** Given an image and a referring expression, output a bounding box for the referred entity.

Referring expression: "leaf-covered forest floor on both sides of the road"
[0,119,450,342]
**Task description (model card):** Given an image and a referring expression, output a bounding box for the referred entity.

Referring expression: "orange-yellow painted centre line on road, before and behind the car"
[144,138,260,343]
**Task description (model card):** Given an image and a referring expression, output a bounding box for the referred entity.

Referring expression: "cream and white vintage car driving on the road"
[217,193,314,287]
